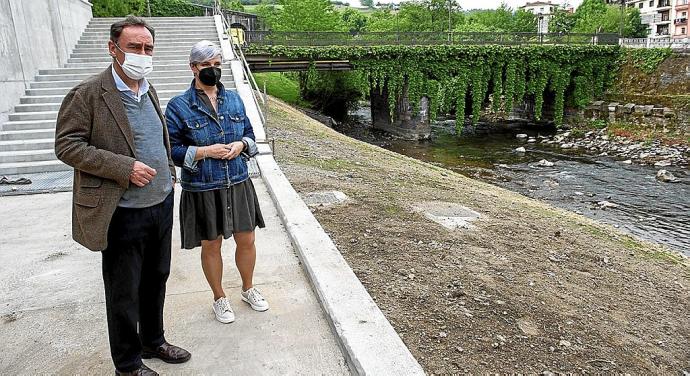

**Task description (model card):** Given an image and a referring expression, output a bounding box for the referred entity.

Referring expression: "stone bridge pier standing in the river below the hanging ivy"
[369,77,431,140]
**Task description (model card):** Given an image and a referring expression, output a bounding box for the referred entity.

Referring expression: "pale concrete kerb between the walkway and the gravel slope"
[257,145,424,375]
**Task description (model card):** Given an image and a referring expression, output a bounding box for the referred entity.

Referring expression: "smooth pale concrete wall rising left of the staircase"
[0,0,92,122]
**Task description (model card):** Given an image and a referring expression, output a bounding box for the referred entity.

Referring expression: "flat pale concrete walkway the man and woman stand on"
[0,179,349,375]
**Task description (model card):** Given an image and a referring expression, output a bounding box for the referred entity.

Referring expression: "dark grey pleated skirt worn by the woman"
[180,179,266,249]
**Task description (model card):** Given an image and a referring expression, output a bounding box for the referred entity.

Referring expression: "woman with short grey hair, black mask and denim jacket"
[165,41,268,323]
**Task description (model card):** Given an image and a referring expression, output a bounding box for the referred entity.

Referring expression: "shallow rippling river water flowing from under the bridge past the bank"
[335,108,690,256]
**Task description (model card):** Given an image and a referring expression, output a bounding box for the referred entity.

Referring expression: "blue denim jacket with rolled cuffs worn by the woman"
[165,81,257,192]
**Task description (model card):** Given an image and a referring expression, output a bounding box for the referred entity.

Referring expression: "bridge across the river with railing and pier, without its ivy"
[244,31,619,139]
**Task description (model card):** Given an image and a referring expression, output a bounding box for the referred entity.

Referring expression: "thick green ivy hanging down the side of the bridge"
[250,45,620,124]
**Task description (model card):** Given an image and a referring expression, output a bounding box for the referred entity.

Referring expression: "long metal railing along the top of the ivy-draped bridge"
[245,31,619,46]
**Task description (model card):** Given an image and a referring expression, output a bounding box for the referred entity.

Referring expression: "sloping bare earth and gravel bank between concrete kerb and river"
[268,100,690,375]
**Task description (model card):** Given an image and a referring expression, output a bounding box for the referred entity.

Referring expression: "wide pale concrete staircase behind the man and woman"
[0,17,234,175]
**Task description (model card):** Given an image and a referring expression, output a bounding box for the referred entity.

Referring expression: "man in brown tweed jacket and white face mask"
[55,16,191,375]
